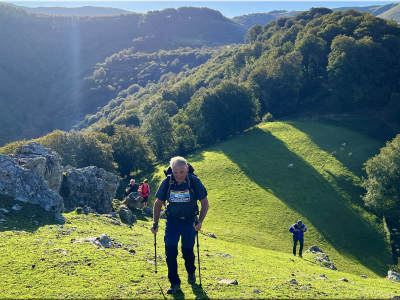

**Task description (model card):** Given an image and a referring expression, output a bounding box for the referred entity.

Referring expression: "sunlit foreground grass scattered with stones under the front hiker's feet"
[0,196,397,299]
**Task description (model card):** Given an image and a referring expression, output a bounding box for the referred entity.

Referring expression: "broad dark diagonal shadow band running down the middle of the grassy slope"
[219,128,388,275]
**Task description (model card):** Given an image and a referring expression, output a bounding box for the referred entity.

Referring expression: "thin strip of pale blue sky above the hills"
[0,0,400,18]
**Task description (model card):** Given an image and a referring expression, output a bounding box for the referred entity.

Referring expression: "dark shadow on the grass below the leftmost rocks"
[0,194,60,232]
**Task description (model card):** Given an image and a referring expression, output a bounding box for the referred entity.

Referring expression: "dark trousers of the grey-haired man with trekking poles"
[164,219,197,284]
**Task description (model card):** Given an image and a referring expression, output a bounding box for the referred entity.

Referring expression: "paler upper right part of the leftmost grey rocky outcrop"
[14,142,63,193]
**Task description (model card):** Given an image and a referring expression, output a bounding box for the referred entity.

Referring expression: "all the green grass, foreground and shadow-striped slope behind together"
[0,122,400,299]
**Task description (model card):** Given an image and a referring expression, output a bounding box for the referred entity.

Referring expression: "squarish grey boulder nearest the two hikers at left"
[60,166,119,214]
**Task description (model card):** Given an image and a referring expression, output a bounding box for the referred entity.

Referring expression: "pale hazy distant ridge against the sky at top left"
[20,6,133,16]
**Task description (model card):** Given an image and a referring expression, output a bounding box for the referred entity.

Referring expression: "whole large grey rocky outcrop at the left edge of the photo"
[0,149,64,215]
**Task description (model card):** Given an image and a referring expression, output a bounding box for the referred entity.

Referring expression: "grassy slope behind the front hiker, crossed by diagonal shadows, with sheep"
[141,122,390,276]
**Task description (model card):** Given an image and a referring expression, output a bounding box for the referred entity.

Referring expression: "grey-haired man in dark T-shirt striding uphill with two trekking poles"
[151,156,209,294]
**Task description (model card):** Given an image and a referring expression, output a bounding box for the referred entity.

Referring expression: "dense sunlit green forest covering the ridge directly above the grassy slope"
[2,8,400,180]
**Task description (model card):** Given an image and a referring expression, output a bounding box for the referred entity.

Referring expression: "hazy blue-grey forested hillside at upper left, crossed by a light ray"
[0,3,246,145]
